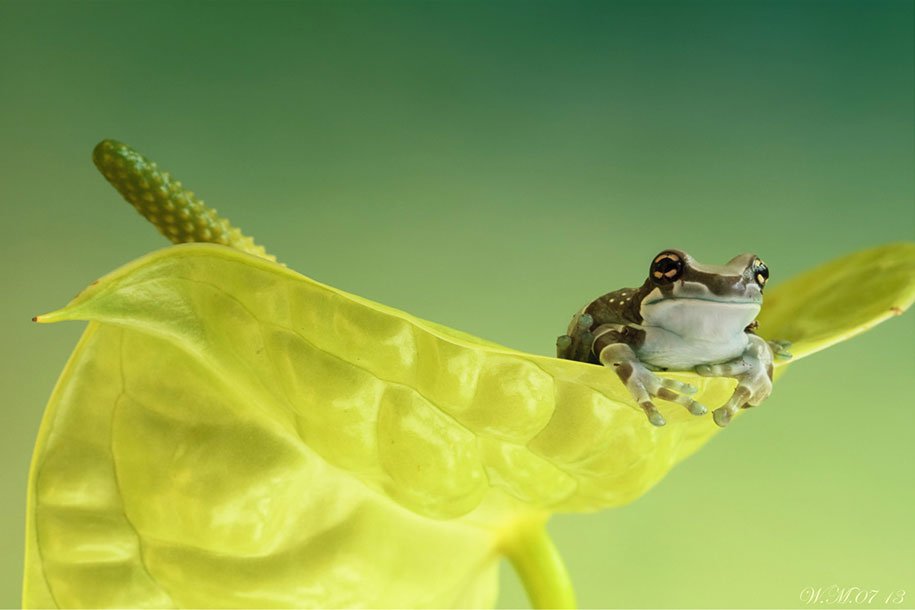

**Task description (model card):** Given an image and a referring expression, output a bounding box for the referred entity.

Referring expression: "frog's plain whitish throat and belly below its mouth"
[635,299,759,370]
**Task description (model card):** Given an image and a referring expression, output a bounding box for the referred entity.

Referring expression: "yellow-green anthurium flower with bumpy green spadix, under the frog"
[23,144,915,607]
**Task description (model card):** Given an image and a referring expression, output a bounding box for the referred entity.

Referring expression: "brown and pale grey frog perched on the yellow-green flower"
[556,249,791,428]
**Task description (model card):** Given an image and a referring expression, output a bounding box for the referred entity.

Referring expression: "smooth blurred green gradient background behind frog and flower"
[0,0,915,608]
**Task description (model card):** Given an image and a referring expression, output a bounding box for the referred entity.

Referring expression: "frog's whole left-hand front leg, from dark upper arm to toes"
[592,324,708,426]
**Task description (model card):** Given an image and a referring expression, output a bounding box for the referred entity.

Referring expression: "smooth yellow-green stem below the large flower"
[502,520,575,608]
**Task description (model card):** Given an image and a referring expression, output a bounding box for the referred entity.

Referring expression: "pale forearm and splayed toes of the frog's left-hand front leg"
[600,343,708,426]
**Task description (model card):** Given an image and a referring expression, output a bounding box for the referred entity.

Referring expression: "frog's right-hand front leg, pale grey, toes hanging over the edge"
[696,333,776,428]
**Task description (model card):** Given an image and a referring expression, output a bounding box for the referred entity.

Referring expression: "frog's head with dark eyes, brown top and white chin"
[640,250,769,339]
